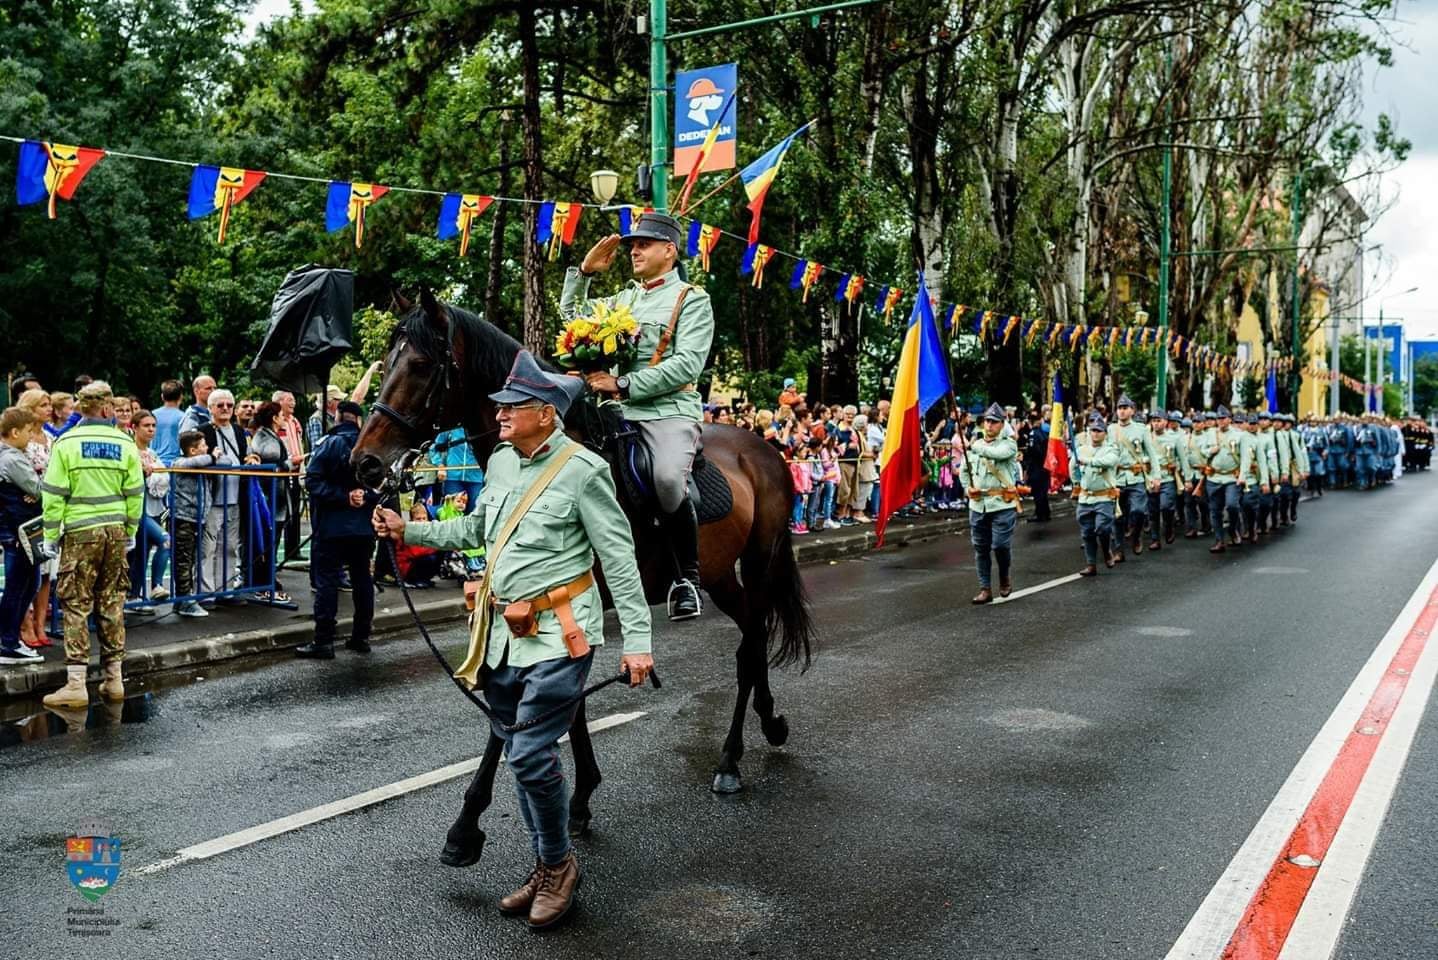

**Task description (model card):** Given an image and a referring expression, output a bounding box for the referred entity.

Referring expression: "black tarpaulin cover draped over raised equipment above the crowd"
[250,264,355,394]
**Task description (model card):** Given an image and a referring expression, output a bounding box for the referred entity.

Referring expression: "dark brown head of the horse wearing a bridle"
[349,290,463,490]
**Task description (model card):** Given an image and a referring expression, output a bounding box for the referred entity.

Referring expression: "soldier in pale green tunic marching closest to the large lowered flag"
[963,404,1018,604]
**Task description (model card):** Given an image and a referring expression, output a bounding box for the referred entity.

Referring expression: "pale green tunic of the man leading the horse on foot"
[404,430,651,668]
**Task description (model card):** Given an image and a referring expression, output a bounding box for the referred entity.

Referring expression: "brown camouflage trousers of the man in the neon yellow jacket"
[55,526,129,665]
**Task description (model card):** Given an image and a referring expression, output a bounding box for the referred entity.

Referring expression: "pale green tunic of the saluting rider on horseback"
[559,267,715,423]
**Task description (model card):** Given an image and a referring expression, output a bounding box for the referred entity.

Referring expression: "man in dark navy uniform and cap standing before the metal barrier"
[295,400,380,660]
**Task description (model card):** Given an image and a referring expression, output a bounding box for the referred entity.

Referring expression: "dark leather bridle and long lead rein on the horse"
[371,336,660,733]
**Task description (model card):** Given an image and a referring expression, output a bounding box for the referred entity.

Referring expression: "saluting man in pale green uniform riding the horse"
[559,213,715,621]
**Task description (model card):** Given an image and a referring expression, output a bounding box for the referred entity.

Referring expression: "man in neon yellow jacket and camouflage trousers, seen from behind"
[40,379,145,707]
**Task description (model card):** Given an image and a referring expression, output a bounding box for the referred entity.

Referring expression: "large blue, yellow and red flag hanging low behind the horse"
[874,273,949,546]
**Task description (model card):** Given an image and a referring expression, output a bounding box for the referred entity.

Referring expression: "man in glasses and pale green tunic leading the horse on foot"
[374,351,654,930]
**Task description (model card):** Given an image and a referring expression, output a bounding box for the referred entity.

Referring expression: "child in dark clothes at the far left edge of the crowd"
[0,407,43,664]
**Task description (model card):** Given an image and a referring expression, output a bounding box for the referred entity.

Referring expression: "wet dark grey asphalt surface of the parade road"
[8,474,1438,960]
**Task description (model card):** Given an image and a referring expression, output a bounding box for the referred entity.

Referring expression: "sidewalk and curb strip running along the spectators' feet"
[0,497,1073,700]
